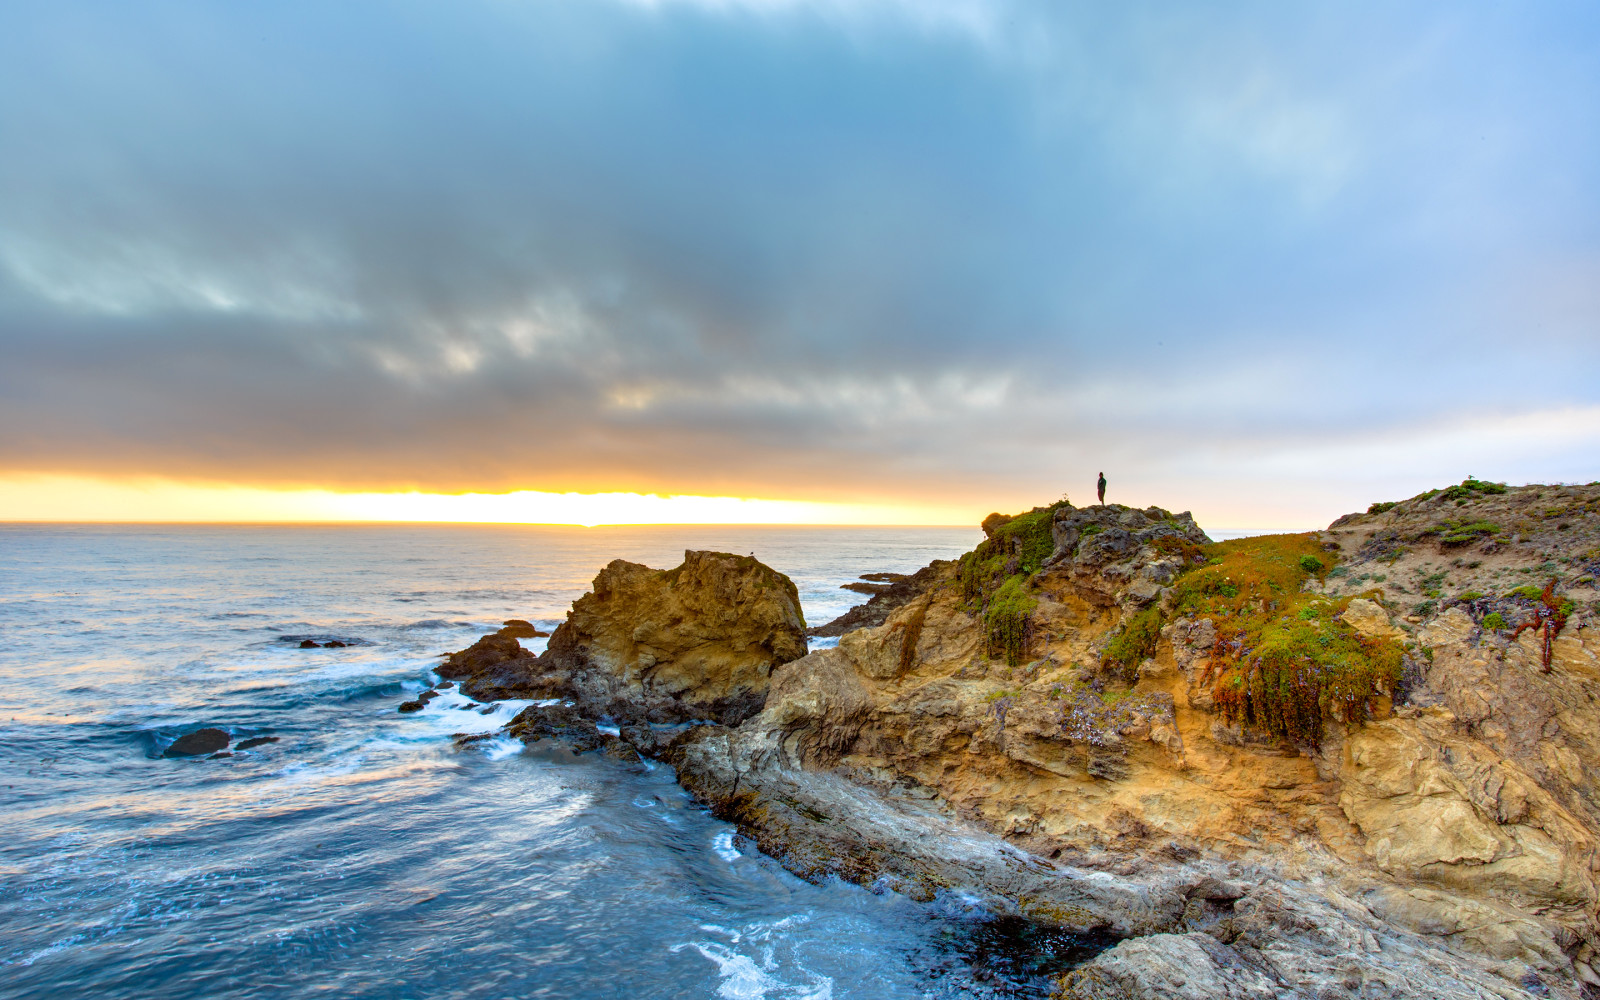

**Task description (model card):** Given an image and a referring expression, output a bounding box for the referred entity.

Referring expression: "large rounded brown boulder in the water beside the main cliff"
[539,552,806,725]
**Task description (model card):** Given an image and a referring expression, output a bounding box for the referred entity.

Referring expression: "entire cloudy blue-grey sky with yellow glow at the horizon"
[0,0,1600,530]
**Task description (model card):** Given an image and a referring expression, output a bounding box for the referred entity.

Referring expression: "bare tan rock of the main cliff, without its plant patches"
[674,488,1600,998]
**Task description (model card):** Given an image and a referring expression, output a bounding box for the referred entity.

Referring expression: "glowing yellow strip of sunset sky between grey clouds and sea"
[0,475,973,525]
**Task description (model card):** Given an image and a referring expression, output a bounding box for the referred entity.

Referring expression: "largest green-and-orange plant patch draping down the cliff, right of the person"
[1171,534,1403,747]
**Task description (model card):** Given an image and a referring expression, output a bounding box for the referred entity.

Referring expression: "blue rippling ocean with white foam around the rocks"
[0,525,1132,1000]
